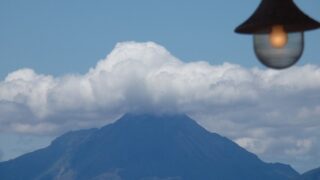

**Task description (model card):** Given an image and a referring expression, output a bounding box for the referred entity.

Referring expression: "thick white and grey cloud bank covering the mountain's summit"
[0,42,320,170]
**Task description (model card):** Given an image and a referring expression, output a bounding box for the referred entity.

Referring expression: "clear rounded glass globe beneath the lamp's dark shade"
[253,32,304,69]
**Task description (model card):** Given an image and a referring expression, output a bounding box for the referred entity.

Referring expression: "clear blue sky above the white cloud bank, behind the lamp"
[0,0,320,78]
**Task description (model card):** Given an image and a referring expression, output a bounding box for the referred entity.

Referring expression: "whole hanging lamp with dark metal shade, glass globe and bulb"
[235,0,320,69]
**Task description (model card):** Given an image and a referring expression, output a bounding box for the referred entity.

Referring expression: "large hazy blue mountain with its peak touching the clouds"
[0,114,299,180]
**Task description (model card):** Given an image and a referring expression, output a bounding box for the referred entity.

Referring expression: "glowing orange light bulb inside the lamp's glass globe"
[269,25,288,49]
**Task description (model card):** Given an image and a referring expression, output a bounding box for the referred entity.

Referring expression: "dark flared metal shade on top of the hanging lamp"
[235,0,320,34]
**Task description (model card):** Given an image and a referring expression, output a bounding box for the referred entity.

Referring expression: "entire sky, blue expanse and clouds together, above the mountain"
[0,0,320,172]
